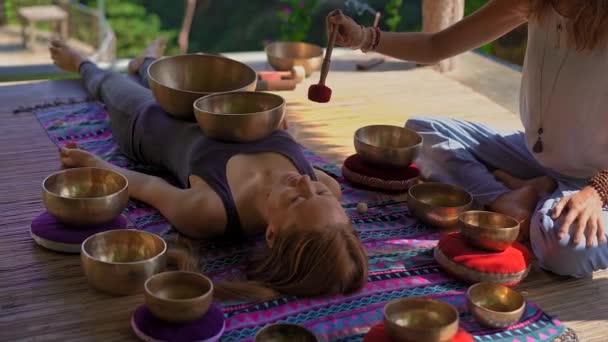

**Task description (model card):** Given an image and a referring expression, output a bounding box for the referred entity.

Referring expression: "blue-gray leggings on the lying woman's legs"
[80,58,155,159]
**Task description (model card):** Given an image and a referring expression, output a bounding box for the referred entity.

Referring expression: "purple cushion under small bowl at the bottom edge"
[131,304,225,342]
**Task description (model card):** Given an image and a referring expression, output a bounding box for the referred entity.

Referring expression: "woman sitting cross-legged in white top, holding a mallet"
[328,0,608,277]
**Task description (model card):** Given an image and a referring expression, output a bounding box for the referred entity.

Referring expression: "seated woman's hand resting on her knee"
[552,186,606,248]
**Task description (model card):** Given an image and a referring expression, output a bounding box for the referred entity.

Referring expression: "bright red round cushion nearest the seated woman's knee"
[434,233,532,285]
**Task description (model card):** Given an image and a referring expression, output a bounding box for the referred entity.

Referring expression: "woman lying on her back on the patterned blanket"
[50,40,367,299]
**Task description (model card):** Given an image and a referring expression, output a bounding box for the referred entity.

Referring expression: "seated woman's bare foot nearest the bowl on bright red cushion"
[488,185,540,241]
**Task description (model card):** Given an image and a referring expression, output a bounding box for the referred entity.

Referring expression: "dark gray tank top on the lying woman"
[131,102,316,236]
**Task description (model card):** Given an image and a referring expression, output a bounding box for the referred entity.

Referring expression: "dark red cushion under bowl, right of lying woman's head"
[342,154,420,191]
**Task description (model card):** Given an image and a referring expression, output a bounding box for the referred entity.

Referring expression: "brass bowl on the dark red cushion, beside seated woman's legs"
[354,125,422,168]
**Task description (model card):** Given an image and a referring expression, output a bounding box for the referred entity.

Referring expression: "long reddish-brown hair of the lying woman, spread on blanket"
[173,224,368,300]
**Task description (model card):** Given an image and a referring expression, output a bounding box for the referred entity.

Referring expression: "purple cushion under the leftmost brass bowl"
[31,211,127,252]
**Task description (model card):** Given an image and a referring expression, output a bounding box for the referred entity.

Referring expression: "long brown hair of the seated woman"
[530,0,608,51]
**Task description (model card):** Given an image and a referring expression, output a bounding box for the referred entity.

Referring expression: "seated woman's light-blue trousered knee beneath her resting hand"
[530,200,608,278]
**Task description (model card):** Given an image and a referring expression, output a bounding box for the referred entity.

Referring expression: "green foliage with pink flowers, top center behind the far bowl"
[277,0,319,42]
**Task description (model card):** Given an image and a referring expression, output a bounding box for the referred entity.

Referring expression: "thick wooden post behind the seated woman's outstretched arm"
[422,0,464,72]
